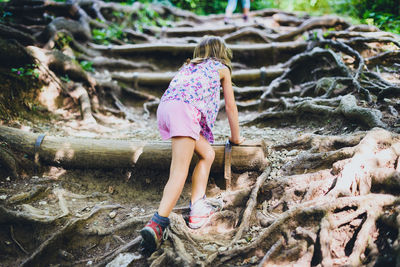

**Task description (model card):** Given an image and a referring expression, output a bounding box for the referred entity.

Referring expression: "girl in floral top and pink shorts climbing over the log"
[140,36,244,252]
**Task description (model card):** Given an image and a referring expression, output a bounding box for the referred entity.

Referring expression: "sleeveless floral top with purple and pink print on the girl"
[161,58,226,143]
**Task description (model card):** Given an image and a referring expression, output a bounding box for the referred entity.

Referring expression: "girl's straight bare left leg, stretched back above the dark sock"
[158,137,196,217]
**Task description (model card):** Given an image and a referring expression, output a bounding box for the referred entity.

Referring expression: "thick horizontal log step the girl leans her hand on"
[0,126,266,173]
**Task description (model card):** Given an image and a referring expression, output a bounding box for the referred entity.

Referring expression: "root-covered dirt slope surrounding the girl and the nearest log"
[0,1,400,267]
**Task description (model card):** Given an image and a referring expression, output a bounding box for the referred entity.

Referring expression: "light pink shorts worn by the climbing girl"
[157,101,201,140]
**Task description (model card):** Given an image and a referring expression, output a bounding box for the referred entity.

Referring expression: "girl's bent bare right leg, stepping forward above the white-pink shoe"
[191,135,215,203]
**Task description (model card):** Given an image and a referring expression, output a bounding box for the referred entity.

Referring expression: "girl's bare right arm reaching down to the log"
[219,68,244,145]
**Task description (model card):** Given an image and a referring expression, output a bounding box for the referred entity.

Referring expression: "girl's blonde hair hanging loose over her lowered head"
[188,35,232,73]
